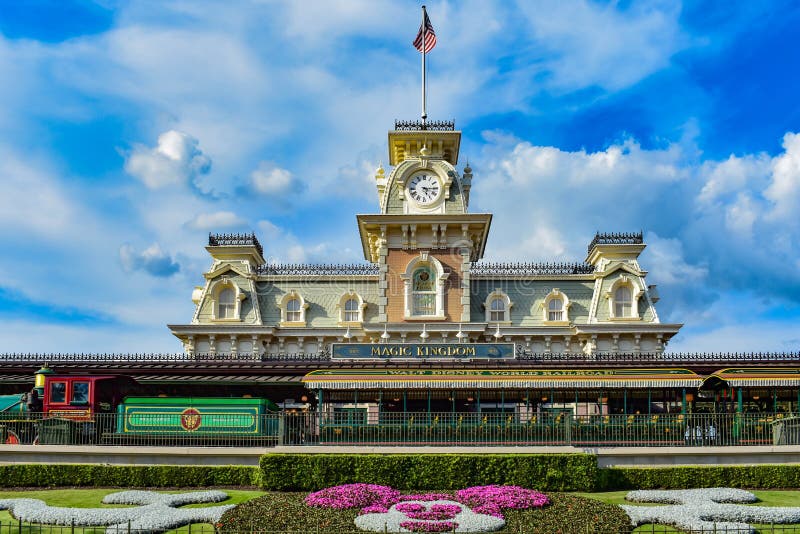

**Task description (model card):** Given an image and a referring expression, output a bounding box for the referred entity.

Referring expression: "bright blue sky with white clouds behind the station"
[0,0,800,352]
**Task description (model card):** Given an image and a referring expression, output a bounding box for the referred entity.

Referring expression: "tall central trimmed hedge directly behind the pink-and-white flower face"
[260,454,598,491]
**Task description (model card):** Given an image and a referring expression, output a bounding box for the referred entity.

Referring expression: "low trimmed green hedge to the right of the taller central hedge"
[598,465,800,490]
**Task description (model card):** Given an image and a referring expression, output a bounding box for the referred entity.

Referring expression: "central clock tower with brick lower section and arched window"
[357,121,492,328]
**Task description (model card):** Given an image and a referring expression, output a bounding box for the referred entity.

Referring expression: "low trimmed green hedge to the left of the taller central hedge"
[0,464,260,488]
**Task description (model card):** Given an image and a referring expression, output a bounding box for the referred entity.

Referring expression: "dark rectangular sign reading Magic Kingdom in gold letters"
[331,343,515,360]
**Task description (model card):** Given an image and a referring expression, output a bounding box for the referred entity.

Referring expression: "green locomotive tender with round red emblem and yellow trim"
[116,397,279,439]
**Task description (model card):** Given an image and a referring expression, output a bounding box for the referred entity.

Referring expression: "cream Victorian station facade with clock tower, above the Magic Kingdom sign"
[170,123,681,359]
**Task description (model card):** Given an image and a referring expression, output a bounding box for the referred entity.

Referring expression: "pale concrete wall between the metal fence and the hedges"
[0,445,800,467]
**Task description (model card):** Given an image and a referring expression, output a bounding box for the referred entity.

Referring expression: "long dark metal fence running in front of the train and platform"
[0,409,800,447]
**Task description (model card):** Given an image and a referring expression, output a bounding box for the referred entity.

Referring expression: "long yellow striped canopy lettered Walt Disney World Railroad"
[303,369,703,390]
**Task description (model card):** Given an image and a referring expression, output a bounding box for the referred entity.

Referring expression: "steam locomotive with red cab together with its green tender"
[0,367,283,446]
